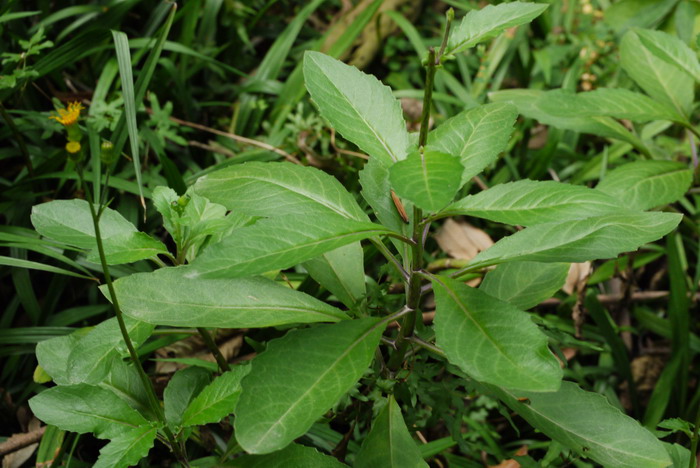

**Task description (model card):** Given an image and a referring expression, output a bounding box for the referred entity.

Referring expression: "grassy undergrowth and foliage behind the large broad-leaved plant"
[0,0,700,467]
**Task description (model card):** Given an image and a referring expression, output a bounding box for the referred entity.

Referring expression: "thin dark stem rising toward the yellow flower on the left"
[76,163,189,466]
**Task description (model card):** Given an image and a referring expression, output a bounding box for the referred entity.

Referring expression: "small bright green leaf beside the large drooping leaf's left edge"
[182,366,250,427]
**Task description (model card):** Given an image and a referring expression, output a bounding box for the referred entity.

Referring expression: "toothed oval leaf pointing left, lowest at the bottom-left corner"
[29,384,148,439]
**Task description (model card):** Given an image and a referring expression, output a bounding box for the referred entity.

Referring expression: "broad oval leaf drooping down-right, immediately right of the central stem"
[433,277,562,392]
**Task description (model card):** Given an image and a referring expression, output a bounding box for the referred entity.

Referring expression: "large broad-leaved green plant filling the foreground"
[21,3,691,468]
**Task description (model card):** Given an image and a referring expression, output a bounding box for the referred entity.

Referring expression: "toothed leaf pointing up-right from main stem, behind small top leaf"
[427,102,516,185]
